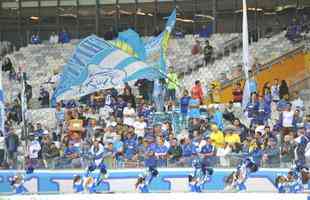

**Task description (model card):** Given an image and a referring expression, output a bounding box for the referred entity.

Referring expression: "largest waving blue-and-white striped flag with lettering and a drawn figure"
[52,35,155,105]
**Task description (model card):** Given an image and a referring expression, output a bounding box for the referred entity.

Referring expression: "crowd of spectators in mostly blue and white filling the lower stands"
[0,64,310,169]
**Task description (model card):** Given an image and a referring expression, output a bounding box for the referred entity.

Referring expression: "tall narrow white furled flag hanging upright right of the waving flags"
[242,0,251,111]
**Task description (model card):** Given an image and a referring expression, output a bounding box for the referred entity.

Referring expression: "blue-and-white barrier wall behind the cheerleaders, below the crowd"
[0,168,306,193]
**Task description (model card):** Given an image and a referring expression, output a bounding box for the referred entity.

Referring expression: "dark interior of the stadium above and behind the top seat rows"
[0,0,310,46]
